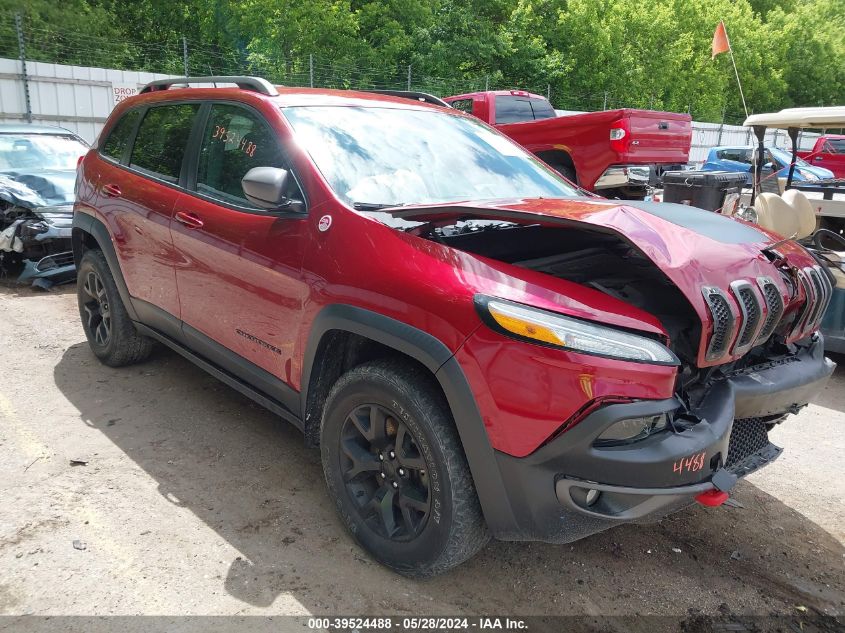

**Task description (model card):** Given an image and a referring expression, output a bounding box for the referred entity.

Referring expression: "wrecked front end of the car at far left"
[0,171,76,289]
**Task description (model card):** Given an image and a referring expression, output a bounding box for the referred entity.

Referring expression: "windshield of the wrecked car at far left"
[0,134,88,171]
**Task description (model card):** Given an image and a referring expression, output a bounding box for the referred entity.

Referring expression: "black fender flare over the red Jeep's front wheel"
[301,304,520,538]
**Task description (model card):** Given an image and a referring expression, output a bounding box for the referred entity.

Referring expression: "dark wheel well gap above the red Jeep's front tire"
[303,330,445,447]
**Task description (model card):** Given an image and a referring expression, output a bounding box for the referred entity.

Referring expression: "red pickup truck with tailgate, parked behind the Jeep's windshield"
[444,90,692,198]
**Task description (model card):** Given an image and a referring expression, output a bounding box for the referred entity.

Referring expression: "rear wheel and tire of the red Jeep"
[76,249,154,367]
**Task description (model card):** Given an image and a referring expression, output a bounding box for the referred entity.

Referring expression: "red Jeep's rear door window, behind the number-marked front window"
[129,103,200,183]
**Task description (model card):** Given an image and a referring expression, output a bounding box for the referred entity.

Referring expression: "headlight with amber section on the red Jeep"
[476,297,680,365]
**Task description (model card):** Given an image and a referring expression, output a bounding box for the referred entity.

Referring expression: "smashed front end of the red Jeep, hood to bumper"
[366,200,835,542]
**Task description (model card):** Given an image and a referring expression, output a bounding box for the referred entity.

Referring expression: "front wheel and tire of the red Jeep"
[320,359,489,577]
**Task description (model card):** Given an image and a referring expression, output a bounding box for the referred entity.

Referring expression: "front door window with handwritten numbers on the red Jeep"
[197,104,302,208]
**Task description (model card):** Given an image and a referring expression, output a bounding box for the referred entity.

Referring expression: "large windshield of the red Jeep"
[283,106,579,208]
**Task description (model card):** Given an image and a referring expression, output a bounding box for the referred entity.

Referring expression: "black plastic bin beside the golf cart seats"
[663,171,748,215]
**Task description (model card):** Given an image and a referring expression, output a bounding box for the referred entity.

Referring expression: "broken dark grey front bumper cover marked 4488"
[497,336,836,543]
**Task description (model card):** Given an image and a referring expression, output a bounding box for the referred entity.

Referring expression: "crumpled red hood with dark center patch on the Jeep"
[384,198,816,365]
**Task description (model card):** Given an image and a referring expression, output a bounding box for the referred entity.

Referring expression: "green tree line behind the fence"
[0,0,845,122]
